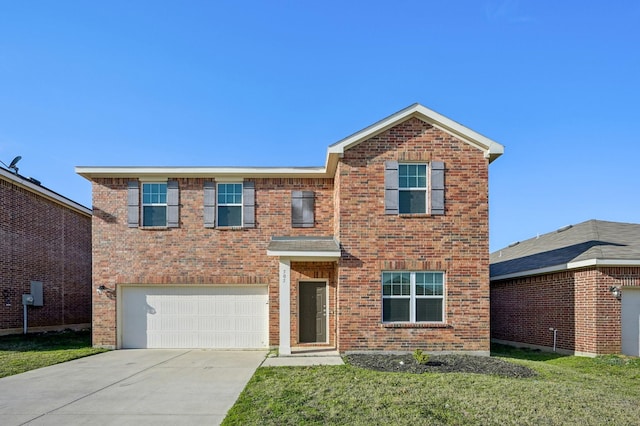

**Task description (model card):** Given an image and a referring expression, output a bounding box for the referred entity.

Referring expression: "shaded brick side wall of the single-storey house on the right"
[491,272,576,350]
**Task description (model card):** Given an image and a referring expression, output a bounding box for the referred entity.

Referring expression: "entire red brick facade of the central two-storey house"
[81,105,501,354]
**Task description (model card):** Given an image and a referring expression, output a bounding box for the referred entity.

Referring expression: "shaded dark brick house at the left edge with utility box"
[0,168,93,334]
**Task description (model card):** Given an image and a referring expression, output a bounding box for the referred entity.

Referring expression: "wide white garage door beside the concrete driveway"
[120,286,269,349]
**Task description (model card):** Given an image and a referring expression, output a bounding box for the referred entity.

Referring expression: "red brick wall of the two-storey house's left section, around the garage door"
[93,178,334,346]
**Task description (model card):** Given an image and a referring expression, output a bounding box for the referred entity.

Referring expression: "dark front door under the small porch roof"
[299,282,327,343]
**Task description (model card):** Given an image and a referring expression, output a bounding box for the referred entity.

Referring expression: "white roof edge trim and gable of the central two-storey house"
[76,103,504,180]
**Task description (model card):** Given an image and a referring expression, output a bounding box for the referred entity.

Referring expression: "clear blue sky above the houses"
[0,0,640,251]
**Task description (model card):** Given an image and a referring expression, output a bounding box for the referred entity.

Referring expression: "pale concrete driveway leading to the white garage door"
[0,349,266,426]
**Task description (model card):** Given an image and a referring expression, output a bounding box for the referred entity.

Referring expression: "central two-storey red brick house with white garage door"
[76,104,503,354]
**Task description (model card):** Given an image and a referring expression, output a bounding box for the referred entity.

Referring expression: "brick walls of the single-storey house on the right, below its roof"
[491,267,640,355]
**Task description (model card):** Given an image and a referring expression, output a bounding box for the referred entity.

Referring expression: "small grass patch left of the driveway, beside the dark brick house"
[0,330,105,378]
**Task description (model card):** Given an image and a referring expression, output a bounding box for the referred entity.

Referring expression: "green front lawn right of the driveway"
[223,346,640,425]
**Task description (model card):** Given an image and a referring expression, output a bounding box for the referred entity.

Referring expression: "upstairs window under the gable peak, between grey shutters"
[398,164,427,214]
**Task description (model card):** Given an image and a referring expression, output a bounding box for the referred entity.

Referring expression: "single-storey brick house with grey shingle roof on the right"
[491,220,640,356]
